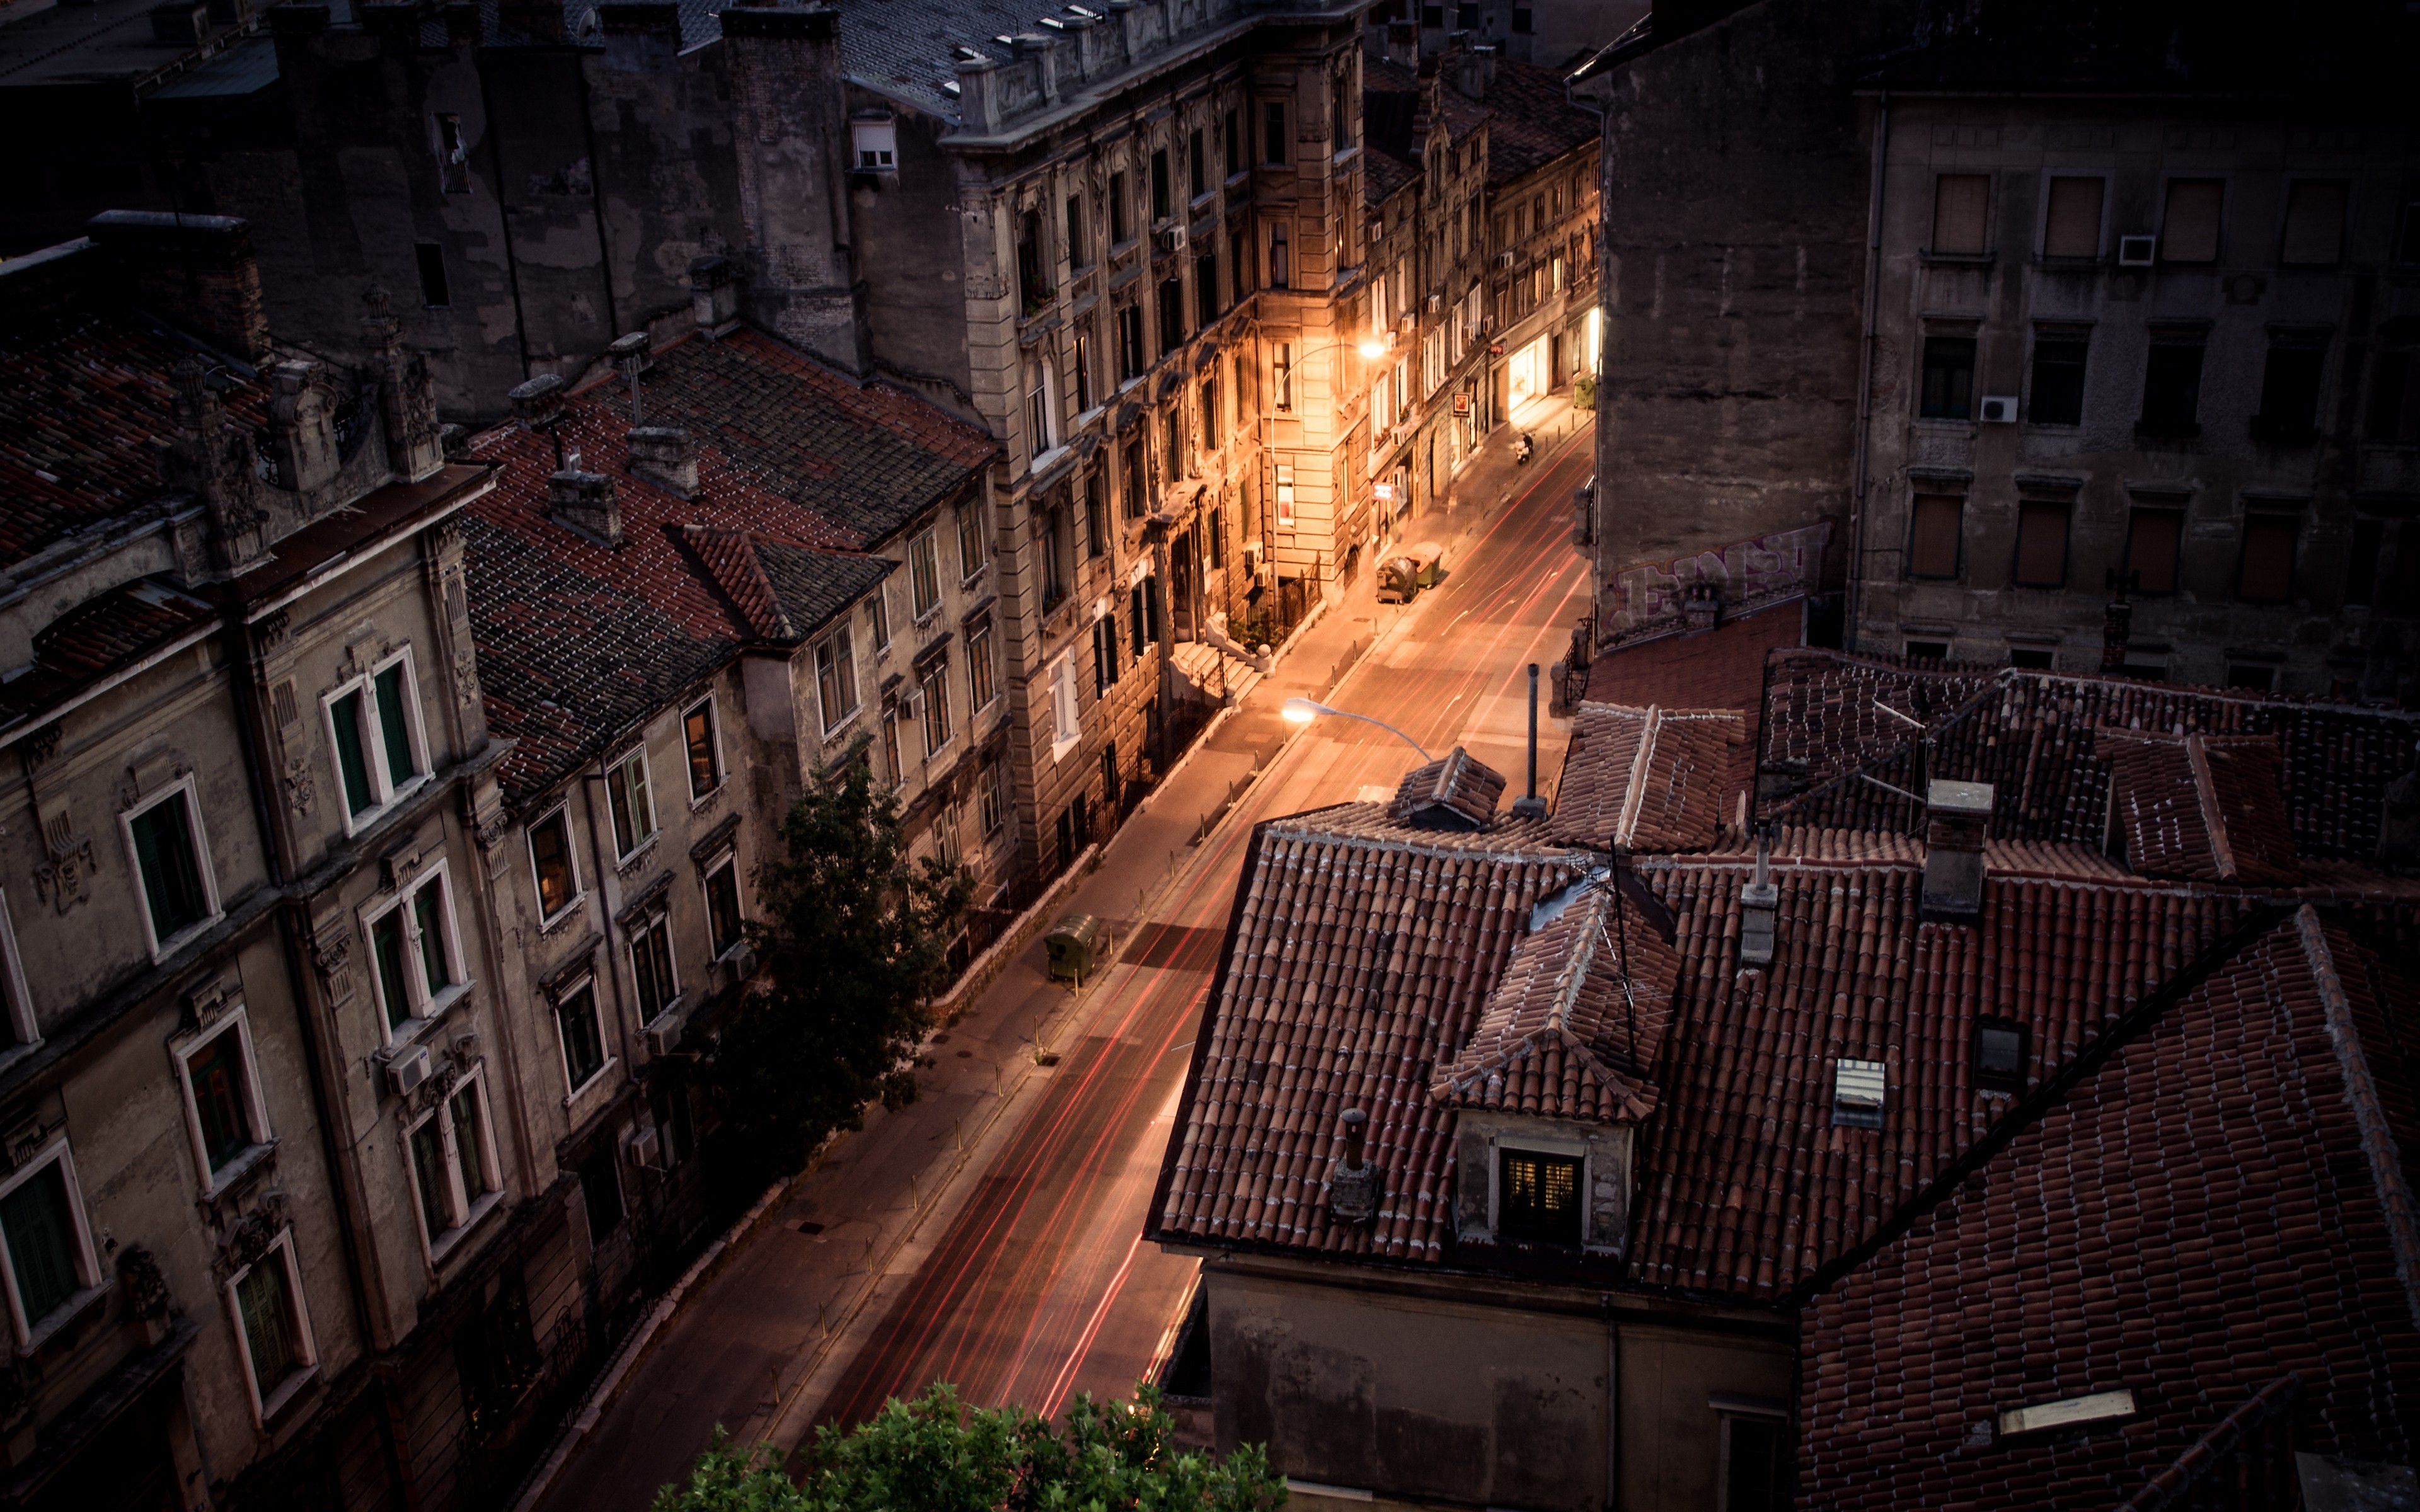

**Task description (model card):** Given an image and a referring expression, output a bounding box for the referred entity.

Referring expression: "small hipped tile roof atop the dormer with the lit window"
[1428,883,1680,1123]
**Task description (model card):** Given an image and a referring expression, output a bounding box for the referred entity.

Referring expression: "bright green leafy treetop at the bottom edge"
[654,1386,1285,1512]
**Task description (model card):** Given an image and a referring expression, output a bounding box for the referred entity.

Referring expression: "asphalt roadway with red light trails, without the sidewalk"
[813,425,1590,1425]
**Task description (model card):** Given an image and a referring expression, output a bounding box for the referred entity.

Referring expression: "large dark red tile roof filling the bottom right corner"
[1798,907,2420,1509]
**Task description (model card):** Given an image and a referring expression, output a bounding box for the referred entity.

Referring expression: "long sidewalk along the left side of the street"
[521,416,1585,1512]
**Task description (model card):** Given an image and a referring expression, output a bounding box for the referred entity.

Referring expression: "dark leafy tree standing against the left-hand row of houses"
[714,762,973,1190]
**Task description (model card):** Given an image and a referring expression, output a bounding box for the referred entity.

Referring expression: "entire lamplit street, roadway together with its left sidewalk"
[539,416,1593,1509]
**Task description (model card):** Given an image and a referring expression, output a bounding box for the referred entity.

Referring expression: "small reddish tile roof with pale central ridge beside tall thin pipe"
[1549,702,1747,852]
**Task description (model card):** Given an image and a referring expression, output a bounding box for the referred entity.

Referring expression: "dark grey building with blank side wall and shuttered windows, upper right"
[1582,5,2420,702]
